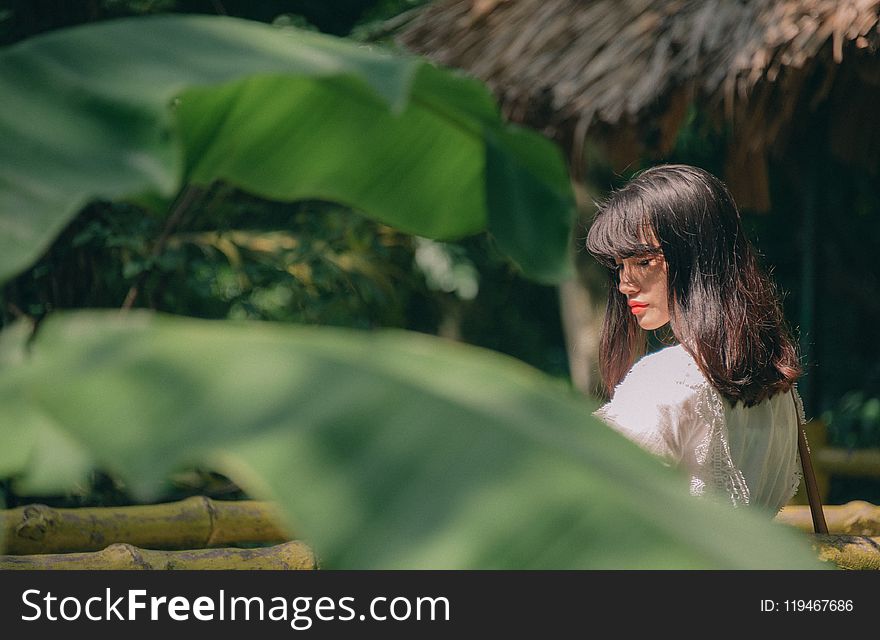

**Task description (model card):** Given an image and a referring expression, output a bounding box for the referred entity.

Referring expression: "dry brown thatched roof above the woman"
[399,0,880,208]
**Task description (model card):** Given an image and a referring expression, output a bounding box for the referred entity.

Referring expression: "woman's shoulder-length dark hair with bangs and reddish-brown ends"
[587,165,801,407]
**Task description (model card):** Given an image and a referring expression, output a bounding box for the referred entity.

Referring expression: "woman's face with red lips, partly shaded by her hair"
[615,254,669,331]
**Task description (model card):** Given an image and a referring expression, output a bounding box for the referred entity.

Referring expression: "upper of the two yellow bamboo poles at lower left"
[0,496,293,555]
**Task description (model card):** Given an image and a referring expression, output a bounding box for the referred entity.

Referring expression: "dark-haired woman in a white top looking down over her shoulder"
[587,165,803,514]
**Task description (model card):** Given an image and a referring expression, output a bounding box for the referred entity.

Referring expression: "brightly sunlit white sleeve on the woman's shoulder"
[593,359,699,465]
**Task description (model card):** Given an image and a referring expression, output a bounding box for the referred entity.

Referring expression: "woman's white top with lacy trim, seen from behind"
[594,345,803,514]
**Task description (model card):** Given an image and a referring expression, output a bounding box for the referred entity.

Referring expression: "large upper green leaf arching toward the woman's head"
[0,15,573,281]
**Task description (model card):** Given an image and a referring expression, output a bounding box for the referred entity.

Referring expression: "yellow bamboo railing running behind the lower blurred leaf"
[0,496,880,570]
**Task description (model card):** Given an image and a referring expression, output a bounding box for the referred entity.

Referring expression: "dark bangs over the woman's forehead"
[586,191,662,269]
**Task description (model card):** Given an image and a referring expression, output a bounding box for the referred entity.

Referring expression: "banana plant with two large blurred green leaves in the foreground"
[0,17,815,568]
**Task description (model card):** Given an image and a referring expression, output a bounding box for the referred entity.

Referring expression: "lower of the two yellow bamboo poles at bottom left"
[0,541,317,570]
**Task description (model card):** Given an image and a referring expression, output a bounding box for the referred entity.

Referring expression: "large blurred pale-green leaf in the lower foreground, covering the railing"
[0,312,820,569]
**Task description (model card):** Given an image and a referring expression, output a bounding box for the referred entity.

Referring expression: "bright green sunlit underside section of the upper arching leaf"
[179,76,486,237]
